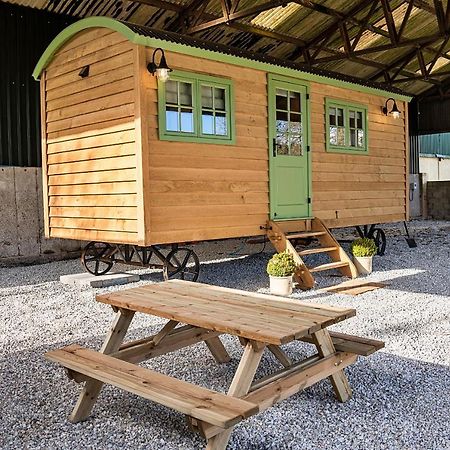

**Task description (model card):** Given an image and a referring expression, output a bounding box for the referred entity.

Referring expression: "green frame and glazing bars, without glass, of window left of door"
[158,70,236,145]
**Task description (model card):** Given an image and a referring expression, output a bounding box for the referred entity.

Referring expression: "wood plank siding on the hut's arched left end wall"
[43,29,138,244]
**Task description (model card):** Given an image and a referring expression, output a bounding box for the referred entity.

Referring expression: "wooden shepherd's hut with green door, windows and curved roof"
[33,17,410,284]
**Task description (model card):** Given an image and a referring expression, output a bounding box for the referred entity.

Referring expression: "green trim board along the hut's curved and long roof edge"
[33,17,412,102]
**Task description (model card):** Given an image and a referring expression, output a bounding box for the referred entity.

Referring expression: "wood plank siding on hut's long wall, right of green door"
[310,83,408,227]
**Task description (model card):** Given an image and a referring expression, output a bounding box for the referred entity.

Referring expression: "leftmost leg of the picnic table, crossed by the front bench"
[69,309,134,423]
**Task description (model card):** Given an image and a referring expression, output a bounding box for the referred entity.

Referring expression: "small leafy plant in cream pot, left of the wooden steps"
[267,250,297,296]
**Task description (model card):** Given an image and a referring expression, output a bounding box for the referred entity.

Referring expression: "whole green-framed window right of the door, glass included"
[325,98,369,154]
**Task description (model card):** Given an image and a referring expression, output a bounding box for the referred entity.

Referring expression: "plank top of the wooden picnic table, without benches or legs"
[96,280,356,345]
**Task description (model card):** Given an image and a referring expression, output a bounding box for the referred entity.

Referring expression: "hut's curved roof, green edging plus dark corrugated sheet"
[33,17,412,101]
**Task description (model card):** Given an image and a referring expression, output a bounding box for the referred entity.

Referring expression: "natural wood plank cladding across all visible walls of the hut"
[41,28,408,245]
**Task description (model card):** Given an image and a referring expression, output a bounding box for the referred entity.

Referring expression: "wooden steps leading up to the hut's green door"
[267,218,358,289]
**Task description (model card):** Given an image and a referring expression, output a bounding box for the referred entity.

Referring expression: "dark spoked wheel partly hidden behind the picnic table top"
[163,248,200,281]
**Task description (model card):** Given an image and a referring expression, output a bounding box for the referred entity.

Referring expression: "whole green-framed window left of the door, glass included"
[158,71,235,145]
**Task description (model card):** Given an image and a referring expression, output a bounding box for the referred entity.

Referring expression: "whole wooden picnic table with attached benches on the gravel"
[46,280,384,450]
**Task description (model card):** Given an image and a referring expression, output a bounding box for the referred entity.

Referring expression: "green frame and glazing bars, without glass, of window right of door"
[325,97,369,155]
